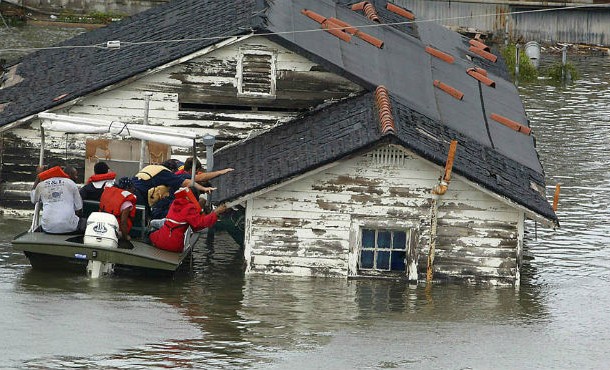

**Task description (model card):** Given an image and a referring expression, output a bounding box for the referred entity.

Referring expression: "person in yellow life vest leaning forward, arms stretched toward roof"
[132,159,233,207]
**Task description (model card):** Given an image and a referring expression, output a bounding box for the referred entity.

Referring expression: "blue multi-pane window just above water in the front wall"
[358,228,410,274]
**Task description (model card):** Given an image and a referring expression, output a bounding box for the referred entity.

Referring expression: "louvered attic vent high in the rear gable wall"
[236,50,276,98]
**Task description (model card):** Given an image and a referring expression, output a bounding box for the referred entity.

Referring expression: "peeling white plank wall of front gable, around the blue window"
[245,148,523,283]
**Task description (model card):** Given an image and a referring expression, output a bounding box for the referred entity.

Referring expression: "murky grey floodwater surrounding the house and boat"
[0,24,610,369]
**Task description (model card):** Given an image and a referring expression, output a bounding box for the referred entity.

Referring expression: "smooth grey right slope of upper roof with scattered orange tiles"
[265,0,543,173]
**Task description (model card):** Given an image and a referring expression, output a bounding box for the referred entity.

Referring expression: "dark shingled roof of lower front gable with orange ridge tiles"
[212,93,557,222]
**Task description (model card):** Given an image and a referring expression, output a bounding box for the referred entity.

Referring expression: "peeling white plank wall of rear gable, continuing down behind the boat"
[0,37,362,210]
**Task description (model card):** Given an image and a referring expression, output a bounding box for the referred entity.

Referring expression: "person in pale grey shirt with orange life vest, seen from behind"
[30,166,87,234]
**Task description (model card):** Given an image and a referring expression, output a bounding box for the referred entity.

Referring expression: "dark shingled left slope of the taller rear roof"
[0,0,261,127]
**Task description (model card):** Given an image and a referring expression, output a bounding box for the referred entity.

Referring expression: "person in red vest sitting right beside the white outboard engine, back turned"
[100,177,137,240]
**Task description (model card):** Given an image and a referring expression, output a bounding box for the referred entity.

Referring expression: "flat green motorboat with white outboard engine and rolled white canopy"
[11,113,213,279]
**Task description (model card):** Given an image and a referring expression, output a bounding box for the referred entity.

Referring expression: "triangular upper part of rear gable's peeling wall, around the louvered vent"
[61,37,362,148]
